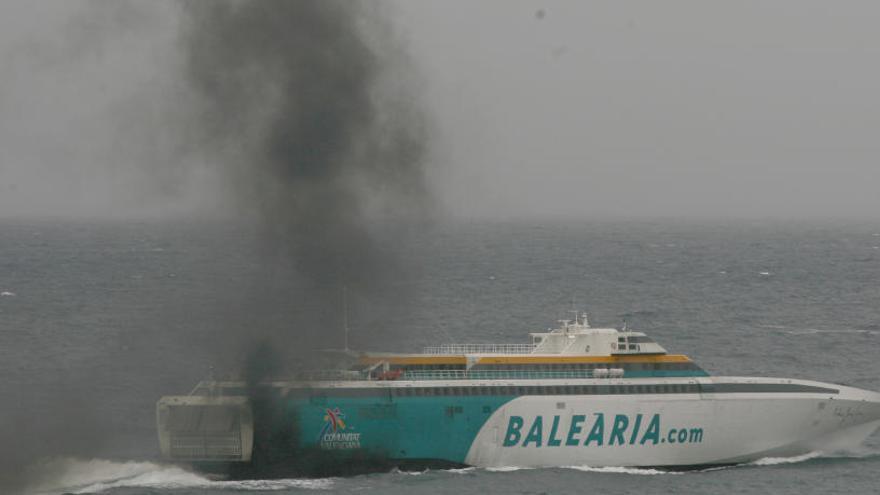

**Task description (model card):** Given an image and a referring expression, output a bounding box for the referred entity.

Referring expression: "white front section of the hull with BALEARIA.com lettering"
[465,387,880,467]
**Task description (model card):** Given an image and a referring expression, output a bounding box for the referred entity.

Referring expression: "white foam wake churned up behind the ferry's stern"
[28,458,333,495]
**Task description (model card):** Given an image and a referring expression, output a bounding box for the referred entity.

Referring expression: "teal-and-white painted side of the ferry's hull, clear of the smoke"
[291,378,880,467]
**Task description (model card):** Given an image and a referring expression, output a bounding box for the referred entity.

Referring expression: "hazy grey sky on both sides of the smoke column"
[0,0,880,218]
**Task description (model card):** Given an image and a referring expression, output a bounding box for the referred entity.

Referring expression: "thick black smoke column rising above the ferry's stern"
[182,0,427,374]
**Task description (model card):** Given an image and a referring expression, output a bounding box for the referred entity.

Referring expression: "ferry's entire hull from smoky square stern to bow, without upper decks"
[159,377,880,476]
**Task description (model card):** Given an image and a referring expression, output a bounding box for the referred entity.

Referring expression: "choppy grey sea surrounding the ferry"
[0,220,880,495]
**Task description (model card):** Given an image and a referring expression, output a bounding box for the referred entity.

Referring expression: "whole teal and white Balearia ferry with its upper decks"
[156,314,880,476]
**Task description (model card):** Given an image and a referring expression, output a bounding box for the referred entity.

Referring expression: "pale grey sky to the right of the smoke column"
[402,1,880,217]
